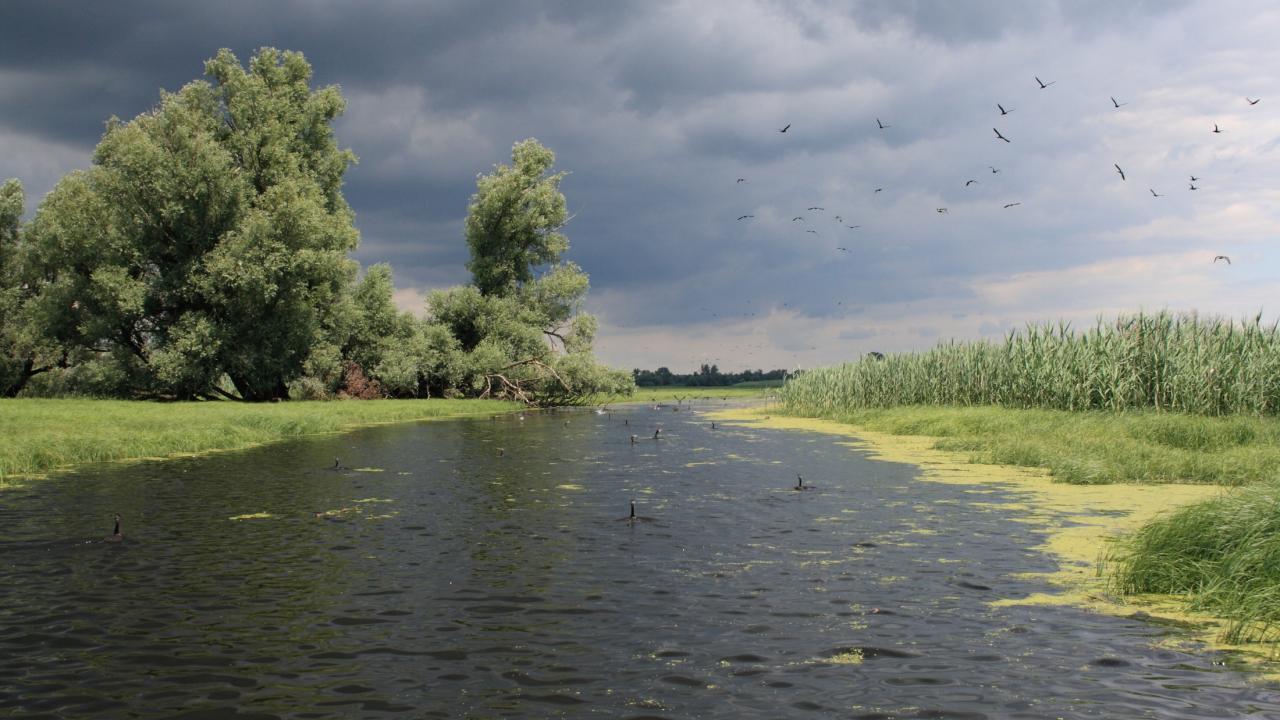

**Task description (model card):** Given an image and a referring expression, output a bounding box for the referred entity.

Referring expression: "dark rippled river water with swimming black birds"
[0,406,1280,719]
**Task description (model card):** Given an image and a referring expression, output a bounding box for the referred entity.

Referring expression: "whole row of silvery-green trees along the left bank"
[0,47,632,402]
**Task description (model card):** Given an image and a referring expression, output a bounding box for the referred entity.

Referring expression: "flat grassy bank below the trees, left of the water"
[0,400,518,482]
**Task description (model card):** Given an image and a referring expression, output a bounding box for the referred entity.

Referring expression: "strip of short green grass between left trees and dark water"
[0,398,526,481]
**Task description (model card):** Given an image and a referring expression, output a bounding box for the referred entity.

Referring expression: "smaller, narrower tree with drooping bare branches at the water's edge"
[440,140,635,404]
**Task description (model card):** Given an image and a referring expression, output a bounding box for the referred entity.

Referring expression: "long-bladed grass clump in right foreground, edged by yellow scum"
[1111,483,1280,642]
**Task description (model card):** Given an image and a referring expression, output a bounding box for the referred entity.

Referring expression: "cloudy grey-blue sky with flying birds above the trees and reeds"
[0,0,1280,373]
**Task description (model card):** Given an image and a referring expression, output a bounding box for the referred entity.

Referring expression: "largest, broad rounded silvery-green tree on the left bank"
[21,47,358,400]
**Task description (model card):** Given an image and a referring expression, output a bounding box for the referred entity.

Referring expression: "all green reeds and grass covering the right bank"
[778,313,1280,641]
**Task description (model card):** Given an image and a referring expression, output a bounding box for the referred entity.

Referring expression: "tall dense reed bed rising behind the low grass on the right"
[781,311,1280,416]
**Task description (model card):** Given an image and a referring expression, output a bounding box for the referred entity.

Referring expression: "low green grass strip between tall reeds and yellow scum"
[786,406,1280,486]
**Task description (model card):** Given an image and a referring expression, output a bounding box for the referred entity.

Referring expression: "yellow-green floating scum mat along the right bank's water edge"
[707,407,1280,682]
